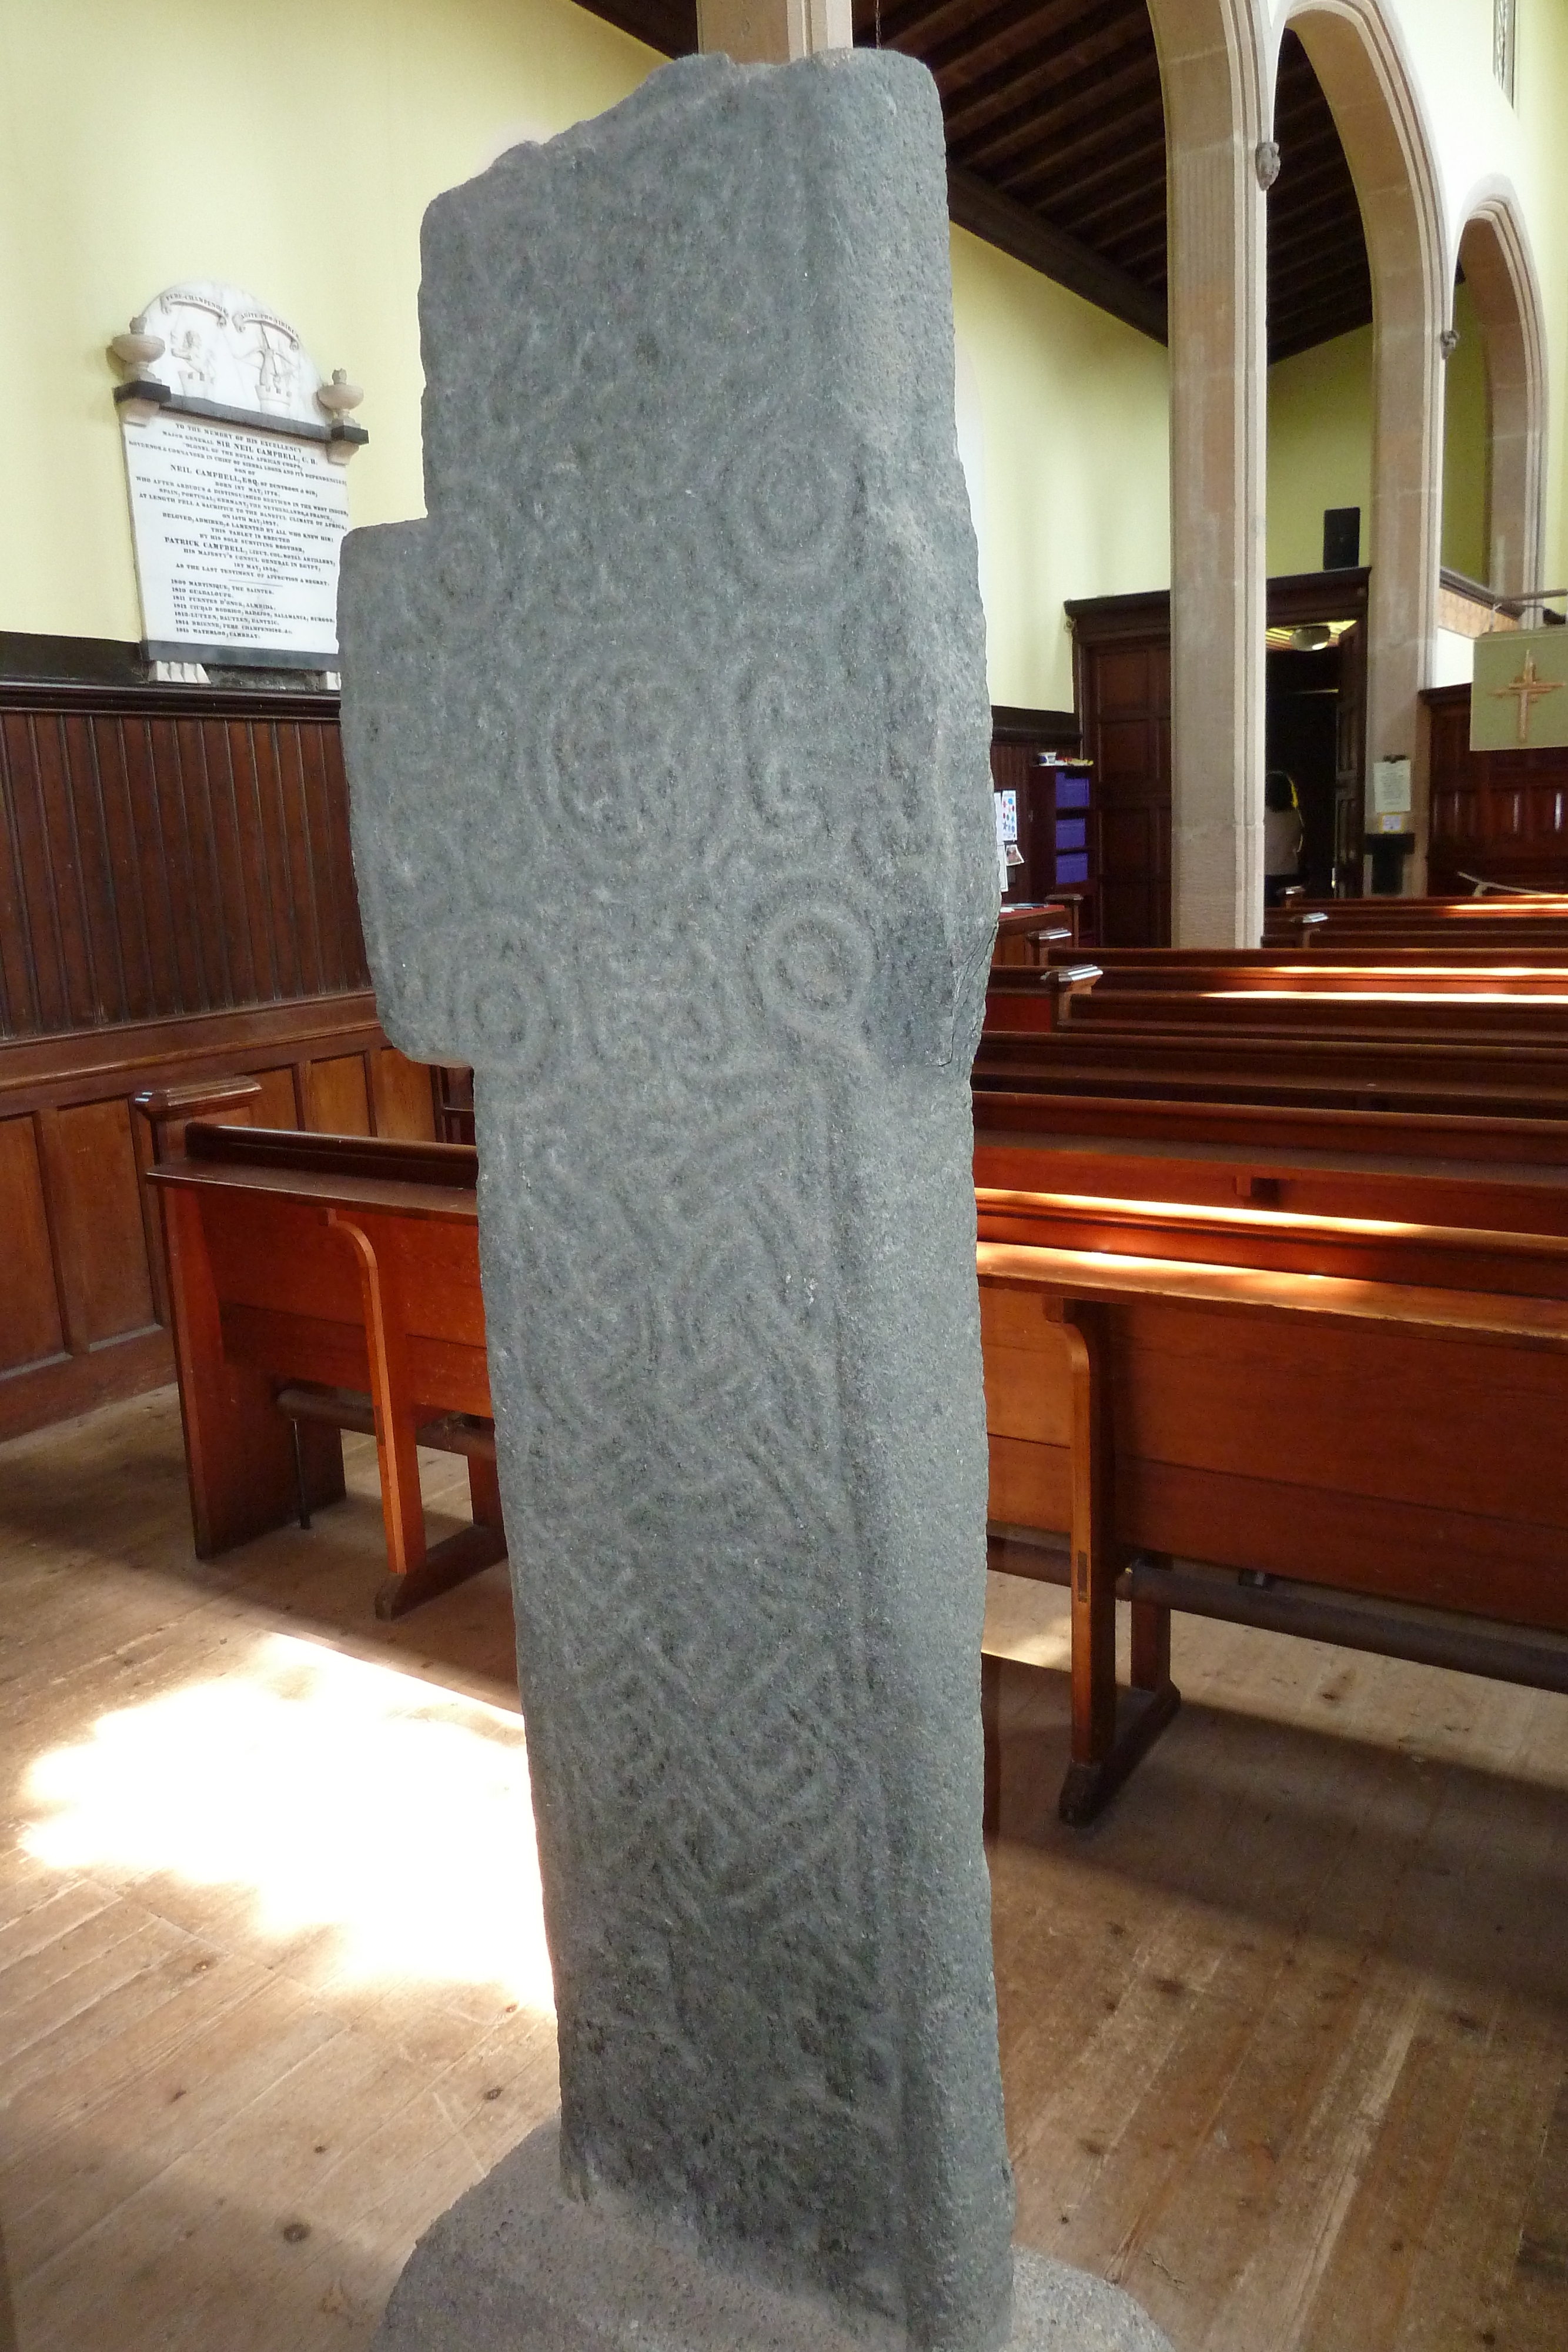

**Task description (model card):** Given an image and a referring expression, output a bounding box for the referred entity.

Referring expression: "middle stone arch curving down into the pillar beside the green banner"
[1274,0,1453,889]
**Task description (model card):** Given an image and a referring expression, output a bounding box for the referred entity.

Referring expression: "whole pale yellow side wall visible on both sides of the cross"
[0,0,1168,706]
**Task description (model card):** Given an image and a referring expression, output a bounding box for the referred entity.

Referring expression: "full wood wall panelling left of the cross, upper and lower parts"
[0,661,433,1435]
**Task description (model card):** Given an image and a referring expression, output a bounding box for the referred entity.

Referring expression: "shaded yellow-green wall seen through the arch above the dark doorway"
[1269,327,1373,579]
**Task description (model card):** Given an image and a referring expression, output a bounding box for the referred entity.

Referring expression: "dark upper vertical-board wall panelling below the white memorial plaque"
[0,684,367,1037]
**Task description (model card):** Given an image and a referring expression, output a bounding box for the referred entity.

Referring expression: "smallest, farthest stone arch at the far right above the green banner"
[1460,181,1556,595]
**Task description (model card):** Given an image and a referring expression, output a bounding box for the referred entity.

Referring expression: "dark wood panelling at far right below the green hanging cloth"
[1422,687,1568,894]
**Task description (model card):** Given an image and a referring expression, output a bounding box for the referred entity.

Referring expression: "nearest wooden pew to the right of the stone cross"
[978,1152,1568,1820]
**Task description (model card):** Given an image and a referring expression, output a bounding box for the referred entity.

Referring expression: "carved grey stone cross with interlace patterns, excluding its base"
[341,54,1142,2352]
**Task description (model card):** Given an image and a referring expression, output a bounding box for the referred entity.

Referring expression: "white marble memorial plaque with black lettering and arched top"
[111,280,367,670]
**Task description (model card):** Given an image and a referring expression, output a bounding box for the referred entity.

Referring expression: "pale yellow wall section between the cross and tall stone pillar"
[952,228,1171,710]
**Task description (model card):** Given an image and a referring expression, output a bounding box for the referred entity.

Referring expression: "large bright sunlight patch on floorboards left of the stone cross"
[24,1635,555,2013]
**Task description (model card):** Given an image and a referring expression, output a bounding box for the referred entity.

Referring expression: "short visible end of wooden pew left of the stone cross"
[139,1094,506,1616]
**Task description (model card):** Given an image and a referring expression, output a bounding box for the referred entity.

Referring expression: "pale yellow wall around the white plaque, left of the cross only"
[0,0,658,637]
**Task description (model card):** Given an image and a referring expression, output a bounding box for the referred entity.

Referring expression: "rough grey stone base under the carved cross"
[374,2122,1171,2352]
